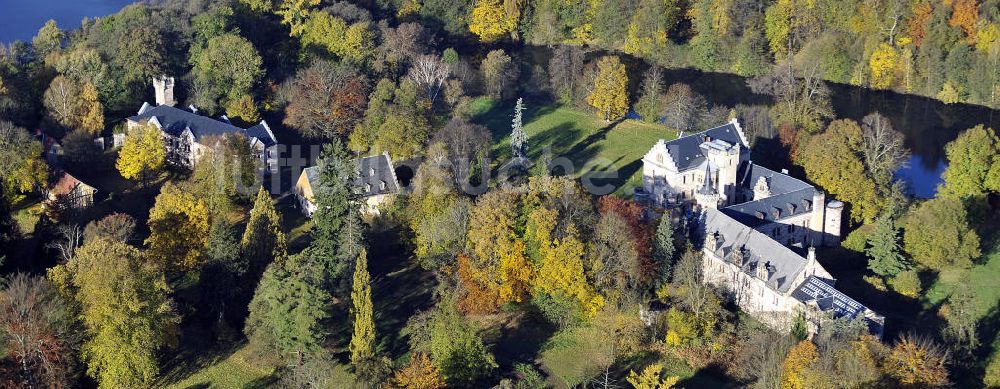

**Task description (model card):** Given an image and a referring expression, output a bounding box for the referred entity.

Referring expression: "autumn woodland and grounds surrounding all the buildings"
[0,0,1000,389]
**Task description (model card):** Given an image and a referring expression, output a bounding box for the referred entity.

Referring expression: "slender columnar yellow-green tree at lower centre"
[350,249,375,366]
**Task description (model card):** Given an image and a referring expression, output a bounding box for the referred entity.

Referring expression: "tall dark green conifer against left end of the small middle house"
[307,139,363,281]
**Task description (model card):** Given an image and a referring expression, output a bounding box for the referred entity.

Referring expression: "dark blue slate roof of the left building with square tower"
[128,103,277,146]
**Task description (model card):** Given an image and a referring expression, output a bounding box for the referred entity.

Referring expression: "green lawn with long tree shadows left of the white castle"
[472,98,677,195]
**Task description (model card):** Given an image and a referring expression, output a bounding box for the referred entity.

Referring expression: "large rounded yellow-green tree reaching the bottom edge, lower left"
[71,238,180,388]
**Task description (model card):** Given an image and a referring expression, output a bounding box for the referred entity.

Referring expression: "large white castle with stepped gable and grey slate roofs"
[638,119,885,336]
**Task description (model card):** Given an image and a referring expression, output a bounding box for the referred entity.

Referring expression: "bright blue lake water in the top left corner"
[0,0,133,43]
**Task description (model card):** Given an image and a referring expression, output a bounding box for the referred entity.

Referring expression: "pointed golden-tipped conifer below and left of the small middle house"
[240,187,287,282]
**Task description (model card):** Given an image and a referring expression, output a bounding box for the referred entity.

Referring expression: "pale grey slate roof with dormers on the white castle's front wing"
[705,209,806,293]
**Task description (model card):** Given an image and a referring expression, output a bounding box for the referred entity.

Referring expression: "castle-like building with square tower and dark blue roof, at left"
[125,76,278,172]
